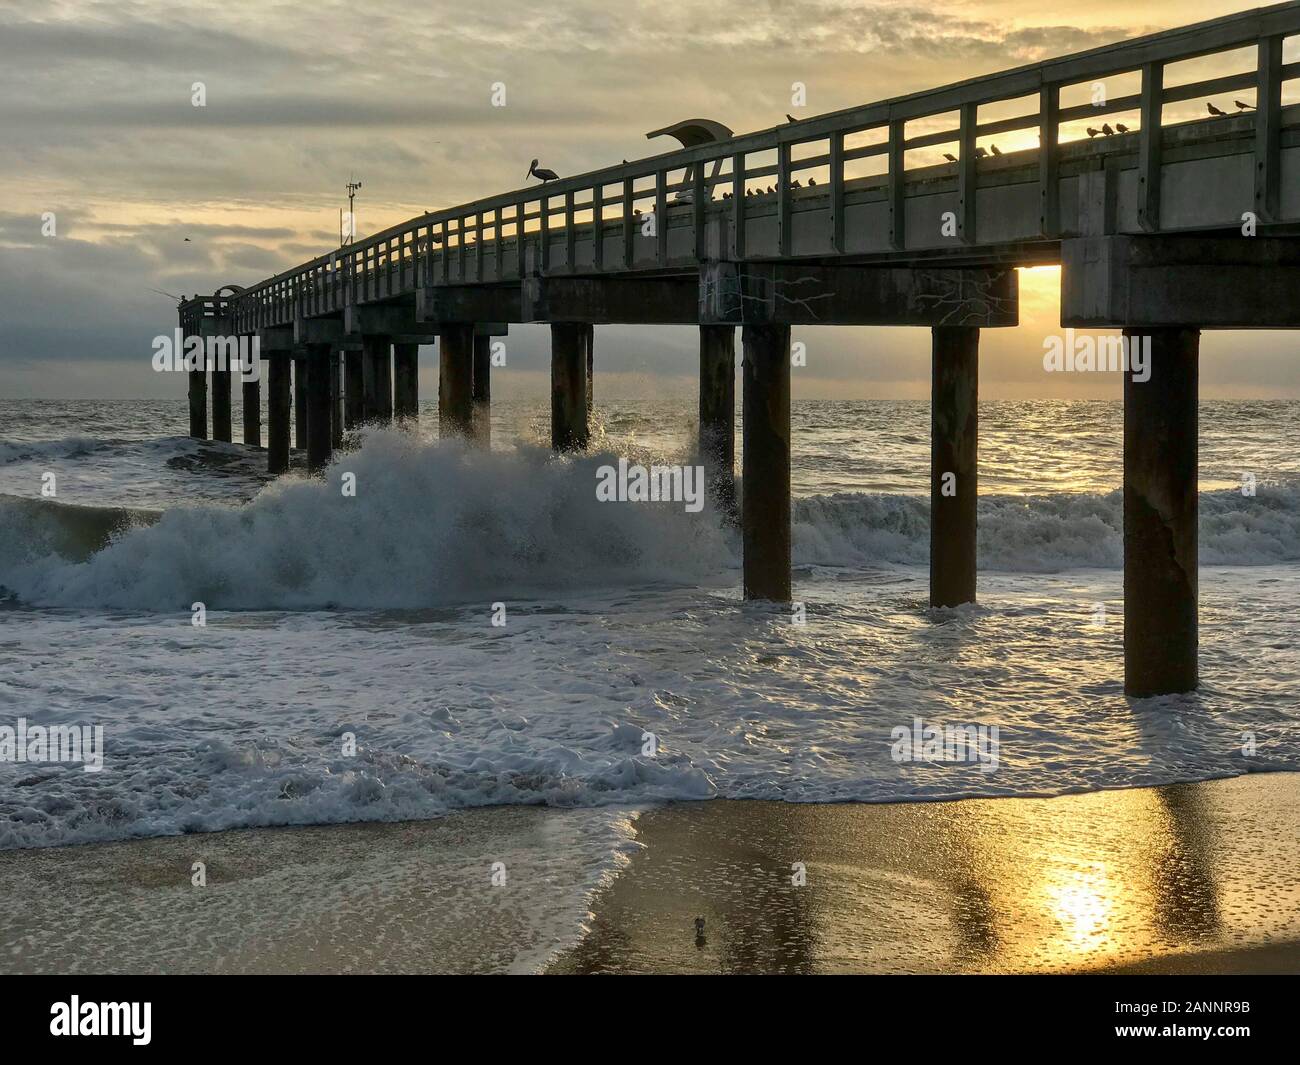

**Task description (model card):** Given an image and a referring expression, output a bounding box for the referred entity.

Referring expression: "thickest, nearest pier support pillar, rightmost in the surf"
[1125,328,1200,698]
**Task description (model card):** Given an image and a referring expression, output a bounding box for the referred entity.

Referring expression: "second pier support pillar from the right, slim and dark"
[930,325,979,606]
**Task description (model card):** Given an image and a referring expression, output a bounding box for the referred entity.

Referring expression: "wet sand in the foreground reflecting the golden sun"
[0,774,1300,973]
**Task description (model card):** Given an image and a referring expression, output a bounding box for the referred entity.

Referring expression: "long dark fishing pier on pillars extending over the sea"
[179,3,1300,697]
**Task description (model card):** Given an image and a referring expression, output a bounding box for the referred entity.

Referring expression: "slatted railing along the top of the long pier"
[205,0,1300,332]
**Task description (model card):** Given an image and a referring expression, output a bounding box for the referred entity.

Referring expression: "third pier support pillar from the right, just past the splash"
[741,325,790,603]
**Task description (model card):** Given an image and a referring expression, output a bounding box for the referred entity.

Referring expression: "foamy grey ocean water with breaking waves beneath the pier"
[0,395,1300,972]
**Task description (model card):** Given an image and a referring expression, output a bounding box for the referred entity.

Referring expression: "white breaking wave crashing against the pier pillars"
[0,430,1300,610]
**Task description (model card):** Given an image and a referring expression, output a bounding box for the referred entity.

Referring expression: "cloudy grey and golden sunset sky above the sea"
[0,0,1300,399]
